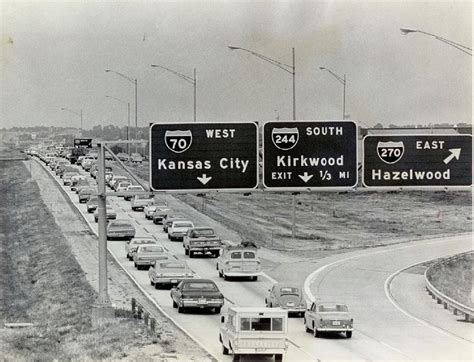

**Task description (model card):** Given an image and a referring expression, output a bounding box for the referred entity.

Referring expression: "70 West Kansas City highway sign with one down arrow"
[150,122,258,191]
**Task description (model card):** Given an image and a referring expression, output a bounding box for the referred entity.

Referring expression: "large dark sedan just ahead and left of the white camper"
[171,279,224,313]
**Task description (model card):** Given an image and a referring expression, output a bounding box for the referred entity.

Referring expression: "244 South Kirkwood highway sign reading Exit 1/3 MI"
[263,121,357,191]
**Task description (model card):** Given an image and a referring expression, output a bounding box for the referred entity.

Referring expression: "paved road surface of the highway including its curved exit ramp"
[39,160,472,361]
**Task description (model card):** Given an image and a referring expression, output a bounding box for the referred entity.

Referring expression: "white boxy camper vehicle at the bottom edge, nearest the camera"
[219,307,288,362]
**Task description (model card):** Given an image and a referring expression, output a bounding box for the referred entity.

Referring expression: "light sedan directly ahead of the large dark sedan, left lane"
[148,260,194,289]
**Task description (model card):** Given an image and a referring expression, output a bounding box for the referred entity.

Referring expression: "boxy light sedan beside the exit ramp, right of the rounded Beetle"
[304,301,354,338]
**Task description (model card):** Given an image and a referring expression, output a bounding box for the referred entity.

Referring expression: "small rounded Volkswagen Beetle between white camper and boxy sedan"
[265,283,306,317]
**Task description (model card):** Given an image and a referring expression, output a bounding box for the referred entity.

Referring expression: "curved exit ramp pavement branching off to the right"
[312,236,472,360]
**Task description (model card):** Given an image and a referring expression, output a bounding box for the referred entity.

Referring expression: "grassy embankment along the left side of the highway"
[0,162,162,360]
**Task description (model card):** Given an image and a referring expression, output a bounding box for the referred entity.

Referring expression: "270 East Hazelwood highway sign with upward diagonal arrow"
[362,134,472,188]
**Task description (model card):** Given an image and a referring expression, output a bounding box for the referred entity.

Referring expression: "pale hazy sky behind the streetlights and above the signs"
[0,0,472,129]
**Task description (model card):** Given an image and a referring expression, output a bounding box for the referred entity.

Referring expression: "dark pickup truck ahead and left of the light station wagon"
[183,227,222,258]
